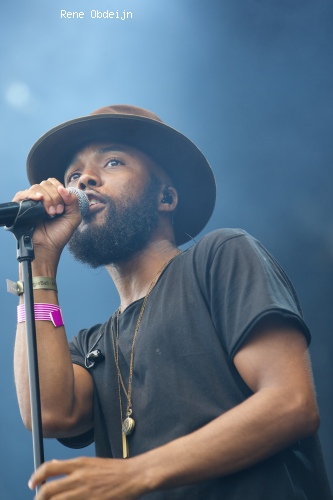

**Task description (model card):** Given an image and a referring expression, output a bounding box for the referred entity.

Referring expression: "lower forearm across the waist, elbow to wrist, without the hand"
[134,389,318,490]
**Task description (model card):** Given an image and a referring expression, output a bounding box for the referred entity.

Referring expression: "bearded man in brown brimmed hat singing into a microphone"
[14,106,331,500]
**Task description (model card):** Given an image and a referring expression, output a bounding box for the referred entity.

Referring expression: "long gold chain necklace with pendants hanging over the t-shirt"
[111,250,181,458]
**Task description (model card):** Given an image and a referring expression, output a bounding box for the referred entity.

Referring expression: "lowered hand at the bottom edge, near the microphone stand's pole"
[28,457,147,500]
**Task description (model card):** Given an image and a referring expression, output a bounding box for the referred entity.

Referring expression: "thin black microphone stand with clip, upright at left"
[5,201,45,493]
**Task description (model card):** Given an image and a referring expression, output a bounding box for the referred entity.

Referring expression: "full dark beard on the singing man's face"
[68,174,161,269]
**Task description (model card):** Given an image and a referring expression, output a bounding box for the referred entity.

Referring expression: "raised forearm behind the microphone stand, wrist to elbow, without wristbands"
[14,262,74,434]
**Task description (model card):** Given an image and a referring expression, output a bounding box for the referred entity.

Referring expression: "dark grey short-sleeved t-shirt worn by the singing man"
[62,229,331,500]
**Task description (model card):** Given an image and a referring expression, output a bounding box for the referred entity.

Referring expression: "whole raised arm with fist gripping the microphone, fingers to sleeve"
[14,179,93,437]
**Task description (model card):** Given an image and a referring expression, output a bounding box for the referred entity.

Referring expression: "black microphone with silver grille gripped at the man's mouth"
[0,188,89,227]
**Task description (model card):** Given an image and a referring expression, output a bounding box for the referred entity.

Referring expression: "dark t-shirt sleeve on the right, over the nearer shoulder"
[201,232,311,358]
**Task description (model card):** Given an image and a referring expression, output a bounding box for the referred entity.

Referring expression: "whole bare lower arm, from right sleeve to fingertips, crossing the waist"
[30,321,319,500]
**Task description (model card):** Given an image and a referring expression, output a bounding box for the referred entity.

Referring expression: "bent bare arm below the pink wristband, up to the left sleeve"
[14,304,93,437]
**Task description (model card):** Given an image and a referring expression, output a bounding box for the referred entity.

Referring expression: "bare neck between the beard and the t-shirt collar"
[106,239,178,311]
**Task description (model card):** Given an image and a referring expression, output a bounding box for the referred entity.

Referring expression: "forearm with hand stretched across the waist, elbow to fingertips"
[29,389,316,499]
